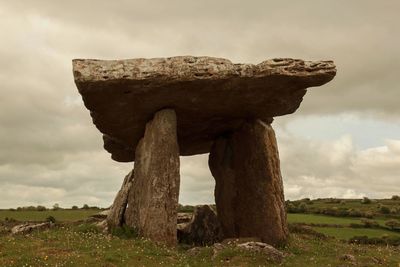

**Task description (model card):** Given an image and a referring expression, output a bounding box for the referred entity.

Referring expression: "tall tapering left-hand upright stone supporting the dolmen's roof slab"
[125,109,180,245]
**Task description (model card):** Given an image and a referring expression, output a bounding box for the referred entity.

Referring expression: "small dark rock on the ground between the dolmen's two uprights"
[178,205,221,246]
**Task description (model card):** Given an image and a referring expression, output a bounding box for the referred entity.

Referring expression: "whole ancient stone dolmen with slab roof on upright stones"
[73,56,336,246]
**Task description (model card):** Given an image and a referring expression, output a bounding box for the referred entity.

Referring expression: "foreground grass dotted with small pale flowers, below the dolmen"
[0,225,400,267]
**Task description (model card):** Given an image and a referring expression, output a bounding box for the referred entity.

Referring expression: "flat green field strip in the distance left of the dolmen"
[0,210,99,222]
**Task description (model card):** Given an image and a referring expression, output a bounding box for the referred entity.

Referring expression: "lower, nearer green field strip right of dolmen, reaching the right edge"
[313,227,400,240]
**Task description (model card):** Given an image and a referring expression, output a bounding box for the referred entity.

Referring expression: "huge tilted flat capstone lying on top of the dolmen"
[73,56,336,161]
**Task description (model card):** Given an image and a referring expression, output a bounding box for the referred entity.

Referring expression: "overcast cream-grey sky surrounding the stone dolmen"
[0,0,400,208]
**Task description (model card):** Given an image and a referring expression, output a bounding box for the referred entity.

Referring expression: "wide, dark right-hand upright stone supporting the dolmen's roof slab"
[209,120,288,245]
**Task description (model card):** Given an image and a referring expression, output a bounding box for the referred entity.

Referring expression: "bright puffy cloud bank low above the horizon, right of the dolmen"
[278,127,400,199]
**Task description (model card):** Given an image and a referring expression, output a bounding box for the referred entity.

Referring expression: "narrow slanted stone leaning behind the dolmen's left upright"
[107,170,134,229]
